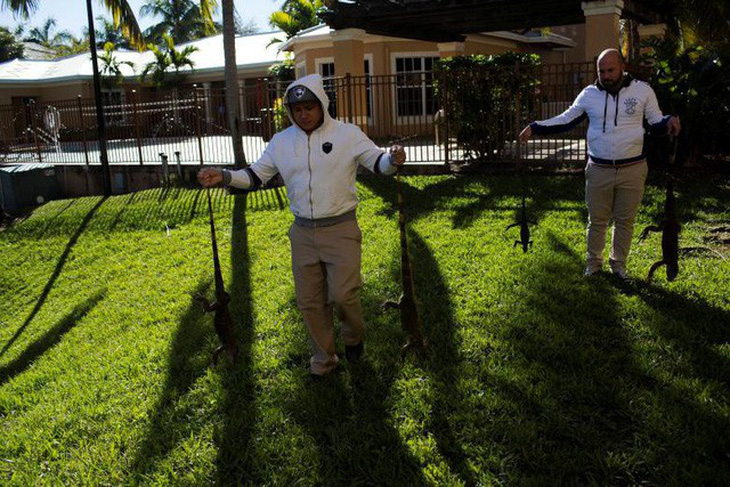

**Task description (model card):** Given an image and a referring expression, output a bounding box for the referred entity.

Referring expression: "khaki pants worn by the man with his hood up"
[289,220,365,375]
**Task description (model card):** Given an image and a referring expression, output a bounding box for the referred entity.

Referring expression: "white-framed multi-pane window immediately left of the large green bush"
[395,56,438,117]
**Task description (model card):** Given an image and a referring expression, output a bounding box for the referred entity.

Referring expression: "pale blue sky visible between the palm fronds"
[0,0,283,37]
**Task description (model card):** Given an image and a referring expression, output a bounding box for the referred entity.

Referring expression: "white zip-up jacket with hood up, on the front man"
[230,74,396,220]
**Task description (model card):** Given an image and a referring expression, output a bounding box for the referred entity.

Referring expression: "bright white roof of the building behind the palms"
[0,31,284,85]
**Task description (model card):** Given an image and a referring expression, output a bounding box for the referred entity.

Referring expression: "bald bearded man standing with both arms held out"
[519,49,681,280]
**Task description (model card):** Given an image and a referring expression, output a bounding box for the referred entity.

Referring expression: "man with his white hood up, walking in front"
[198,74,406,377]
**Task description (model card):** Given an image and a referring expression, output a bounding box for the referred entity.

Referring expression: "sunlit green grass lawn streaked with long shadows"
[0,175,730,486]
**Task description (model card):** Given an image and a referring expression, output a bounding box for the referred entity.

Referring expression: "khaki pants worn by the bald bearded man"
[585,162,648,270]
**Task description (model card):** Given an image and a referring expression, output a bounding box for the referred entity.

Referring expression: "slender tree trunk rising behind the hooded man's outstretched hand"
[222,0,246,167]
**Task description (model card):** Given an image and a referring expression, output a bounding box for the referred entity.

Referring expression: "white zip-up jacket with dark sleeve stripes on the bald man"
[530,73,671,164]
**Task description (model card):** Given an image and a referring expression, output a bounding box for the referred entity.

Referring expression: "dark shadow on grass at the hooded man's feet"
[284,292,426,486]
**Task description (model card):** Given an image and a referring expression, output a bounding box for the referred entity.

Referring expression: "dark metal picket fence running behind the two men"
[0,63,594,165]
